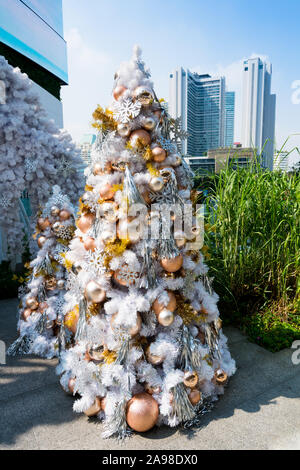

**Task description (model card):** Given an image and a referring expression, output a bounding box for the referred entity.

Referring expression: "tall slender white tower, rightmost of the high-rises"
[242,57,276,169]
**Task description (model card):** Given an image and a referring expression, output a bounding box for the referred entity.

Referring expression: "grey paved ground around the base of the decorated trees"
[0,299,300,450]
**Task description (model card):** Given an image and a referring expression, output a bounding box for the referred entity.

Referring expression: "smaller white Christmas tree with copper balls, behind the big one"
[8,186,75,358]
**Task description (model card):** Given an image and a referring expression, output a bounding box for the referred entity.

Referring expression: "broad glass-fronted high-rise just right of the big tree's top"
[169,67,225,157]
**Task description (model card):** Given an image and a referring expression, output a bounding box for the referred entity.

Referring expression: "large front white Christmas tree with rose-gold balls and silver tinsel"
[57,48,235,437]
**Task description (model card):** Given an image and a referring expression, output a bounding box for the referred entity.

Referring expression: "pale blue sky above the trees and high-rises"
[63,0,300,162]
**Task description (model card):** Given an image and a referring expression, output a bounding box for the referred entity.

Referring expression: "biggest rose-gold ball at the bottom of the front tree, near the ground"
[126,393,159,432]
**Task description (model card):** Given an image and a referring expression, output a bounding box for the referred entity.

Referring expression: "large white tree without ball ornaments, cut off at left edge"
[0,56,83,256]
